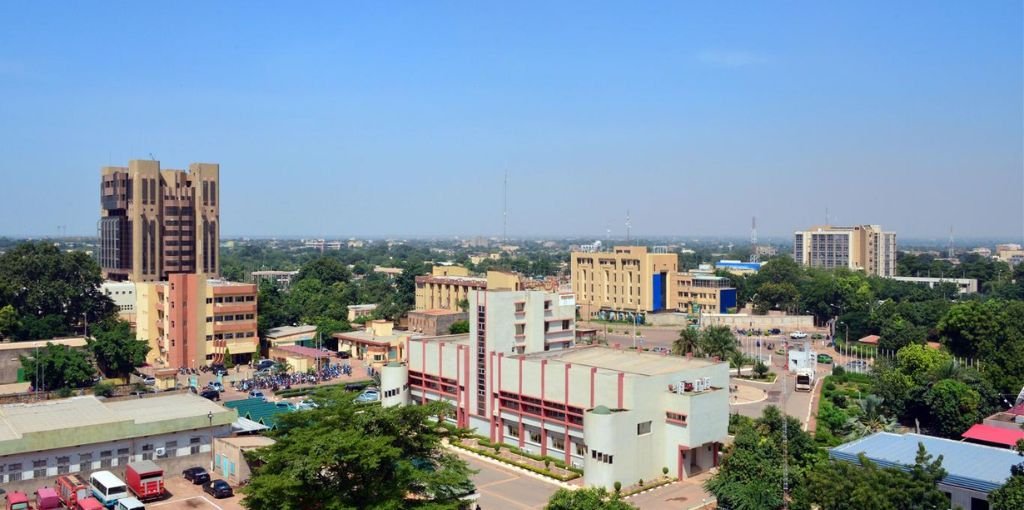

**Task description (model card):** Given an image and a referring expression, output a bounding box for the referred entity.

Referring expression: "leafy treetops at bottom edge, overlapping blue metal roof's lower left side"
[801,444,949,510]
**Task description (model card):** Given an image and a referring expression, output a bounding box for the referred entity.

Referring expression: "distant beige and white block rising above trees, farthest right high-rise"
[793,225,896,278]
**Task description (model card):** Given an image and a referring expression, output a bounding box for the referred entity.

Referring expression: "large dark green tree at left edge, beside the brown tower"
[0,242,114,340]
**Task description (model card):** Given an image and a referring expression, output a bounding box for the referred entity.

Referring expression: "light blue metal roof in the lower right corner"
[828,432,1024,494]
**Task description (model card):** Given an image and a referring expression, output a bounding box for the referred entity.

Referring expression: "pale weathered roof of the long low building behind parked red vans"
[0,393,234,455]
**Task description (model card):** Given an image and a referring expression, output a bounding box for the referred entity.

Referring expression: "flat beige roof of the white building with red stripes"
[526,345,718,376]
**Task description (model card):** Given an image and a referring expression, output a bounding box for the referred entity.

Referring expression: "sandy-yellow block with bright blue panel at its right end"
[570,246,679,320]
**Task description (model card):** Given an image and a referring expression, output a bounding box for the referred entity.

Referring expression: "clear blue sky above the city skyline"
[0,1,1024,240]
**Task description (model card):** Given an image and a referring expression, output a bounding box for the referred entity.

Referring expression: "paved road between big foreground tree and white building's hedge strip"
[459,455,558,510]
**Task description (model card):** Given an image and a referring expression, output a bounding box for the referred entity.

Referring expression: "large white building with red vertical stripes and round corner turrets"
[381,290,729,487]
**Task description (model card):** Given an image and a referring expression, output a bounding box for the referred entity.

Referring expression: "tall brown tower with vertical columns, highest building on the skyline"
[99,160,220,282]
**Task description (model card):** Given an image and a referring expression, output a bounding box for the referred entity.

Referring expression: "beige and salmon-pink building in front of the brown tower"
[136,273,259,369]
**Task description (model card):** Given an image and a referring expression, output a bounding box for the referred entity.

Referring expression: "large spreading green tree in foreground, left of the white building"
[242,388,473,510]
